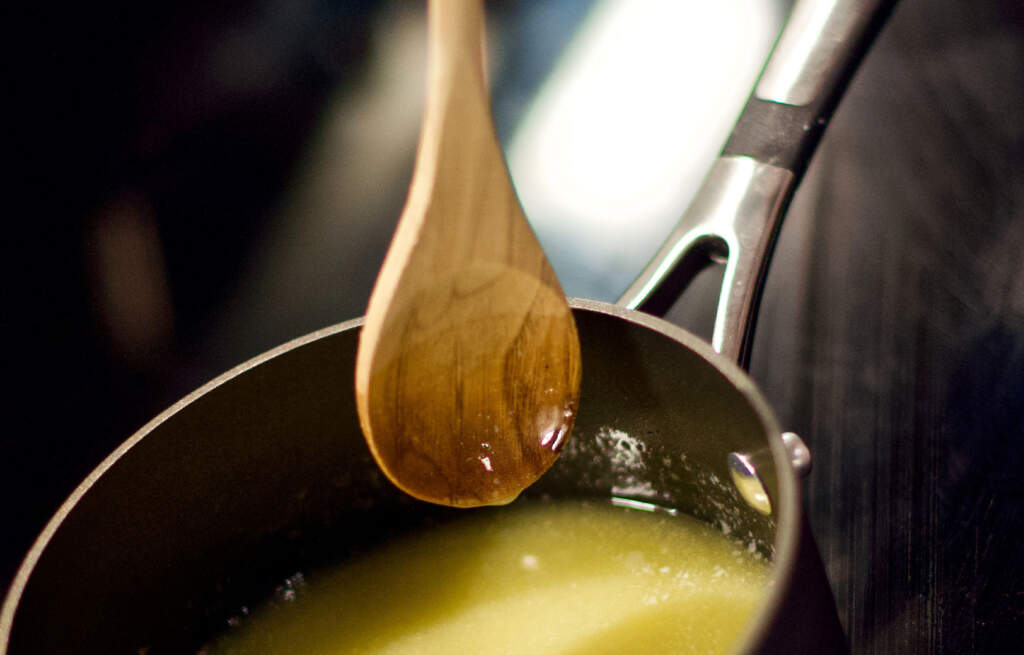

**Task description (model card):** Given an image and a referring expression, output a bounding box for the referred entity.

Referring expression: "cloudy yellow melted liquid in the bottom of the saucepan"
[201,503,769,655]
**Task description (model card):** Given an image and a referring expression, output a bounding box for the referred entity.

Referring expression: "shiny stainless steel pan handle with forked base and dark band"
[618,0,896,368]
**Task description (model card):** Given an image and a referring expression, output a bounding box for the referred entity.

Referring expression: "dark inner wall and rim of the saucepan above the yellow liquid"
[0,301,799,655]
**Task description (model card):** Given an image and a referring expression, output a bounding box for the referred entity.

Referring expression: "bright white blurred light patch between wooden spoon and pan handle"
[508,0,786,300]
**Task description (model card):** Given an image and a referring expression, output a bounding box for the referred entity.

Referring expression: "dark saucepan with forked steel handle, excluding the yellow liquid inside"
[0,0,893,655]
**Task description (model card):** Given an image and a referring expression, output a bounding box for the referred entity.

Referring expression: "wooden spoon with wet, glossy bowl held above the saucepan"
[355,0,581,507]
